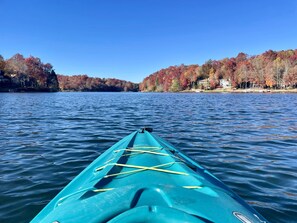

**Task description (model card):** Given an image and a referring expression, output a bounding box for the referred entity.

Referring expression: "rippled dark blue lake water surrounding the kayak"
[0,93,297,223]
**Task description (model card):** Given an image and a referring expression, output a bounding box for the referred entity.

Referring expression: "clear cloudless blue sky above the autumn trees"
[0,0,297,82]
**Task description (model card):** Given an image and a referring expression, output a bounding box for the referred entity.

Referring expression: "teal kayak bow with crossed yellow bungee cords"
[31,128,267,223]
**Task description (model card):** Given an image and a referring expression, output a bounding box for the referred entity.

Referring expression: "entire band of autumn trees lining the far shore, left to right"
[0,50,297,92]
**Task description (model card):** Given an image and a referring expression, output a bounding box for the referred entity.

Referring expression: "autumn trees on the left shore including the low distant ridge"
[0,54,139,92]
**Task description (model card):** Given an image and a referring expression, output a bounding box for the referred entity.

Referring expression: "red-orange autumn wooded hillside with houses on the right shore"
[139,50,297,92]
